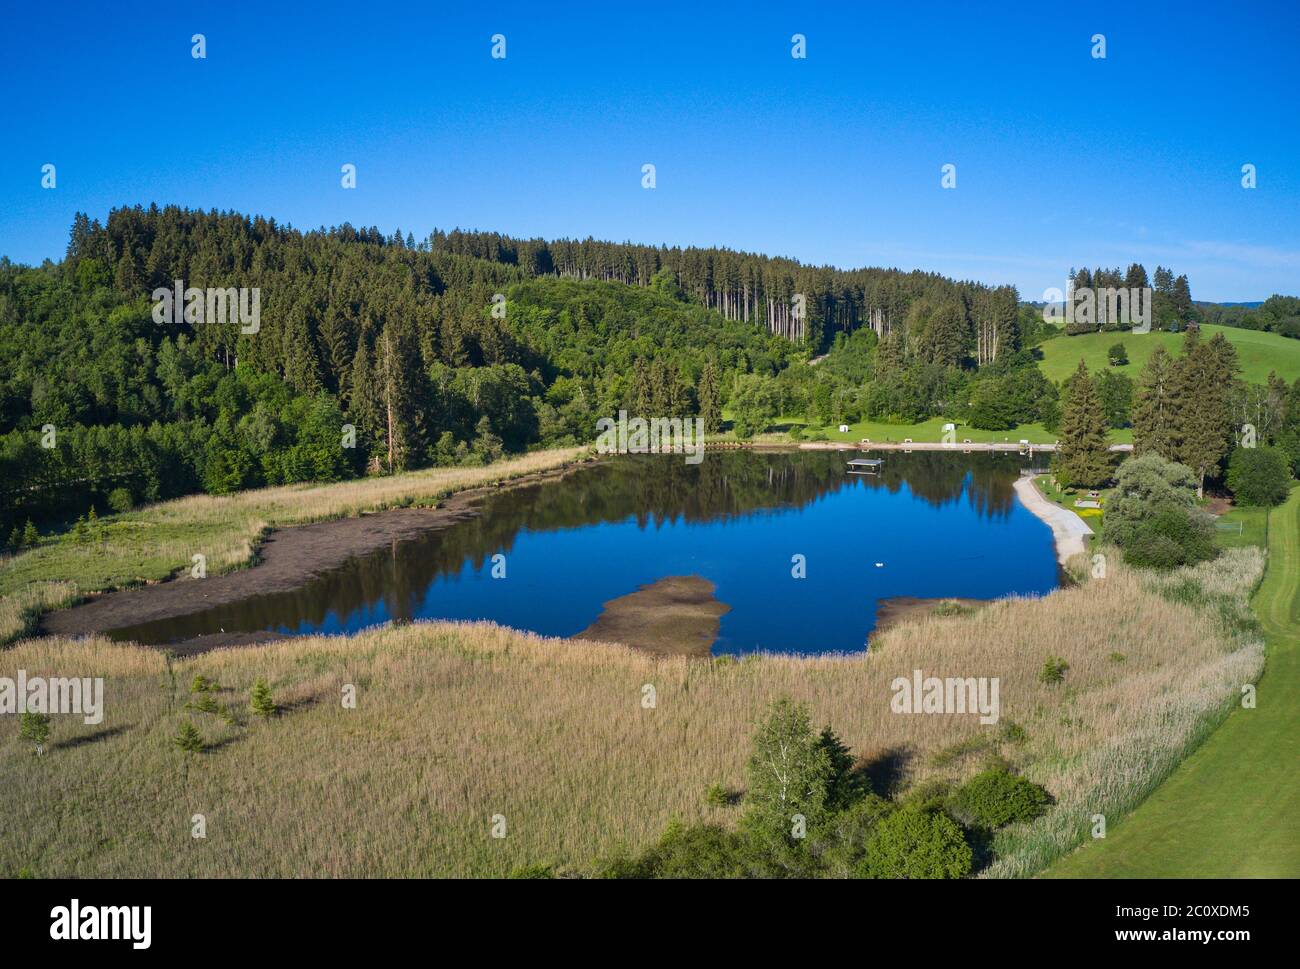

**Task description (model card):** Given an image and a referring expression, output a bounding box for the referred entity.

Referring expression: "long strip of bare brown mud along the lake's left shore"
[38,468,572,653]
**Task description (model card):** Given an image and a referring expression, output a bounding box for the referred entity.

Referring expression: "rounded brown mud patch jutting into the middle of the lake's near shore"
[573,575,731,657]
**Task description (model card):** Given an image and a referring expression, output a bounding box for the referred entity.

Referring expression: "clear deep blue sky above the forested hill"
[0,0,1300,300]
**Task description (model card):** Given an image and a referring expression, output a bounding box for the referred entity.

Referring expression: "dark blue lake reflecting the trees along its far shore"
[113,450,1060,654]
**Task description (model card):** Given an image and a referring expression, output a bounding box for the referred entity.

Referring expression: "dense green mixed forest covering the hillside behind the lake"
[0,206,1294,544]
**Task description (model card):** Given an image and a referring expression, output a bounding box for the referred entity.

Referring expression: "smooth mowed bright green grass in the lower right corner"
[1048,488,1300,878]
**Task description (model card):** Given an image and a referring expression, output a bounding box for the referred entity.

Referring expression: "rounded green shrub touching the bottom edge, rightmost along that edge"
[858,808,974,878]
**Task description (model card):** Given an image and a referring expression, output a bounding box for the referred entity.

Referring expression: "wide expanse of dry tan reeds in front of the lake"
[0,549,1262,877]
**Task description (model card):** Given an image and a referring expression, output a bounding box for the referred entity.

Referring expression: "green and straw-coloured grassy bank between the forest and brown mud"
[0,447,585,645]
